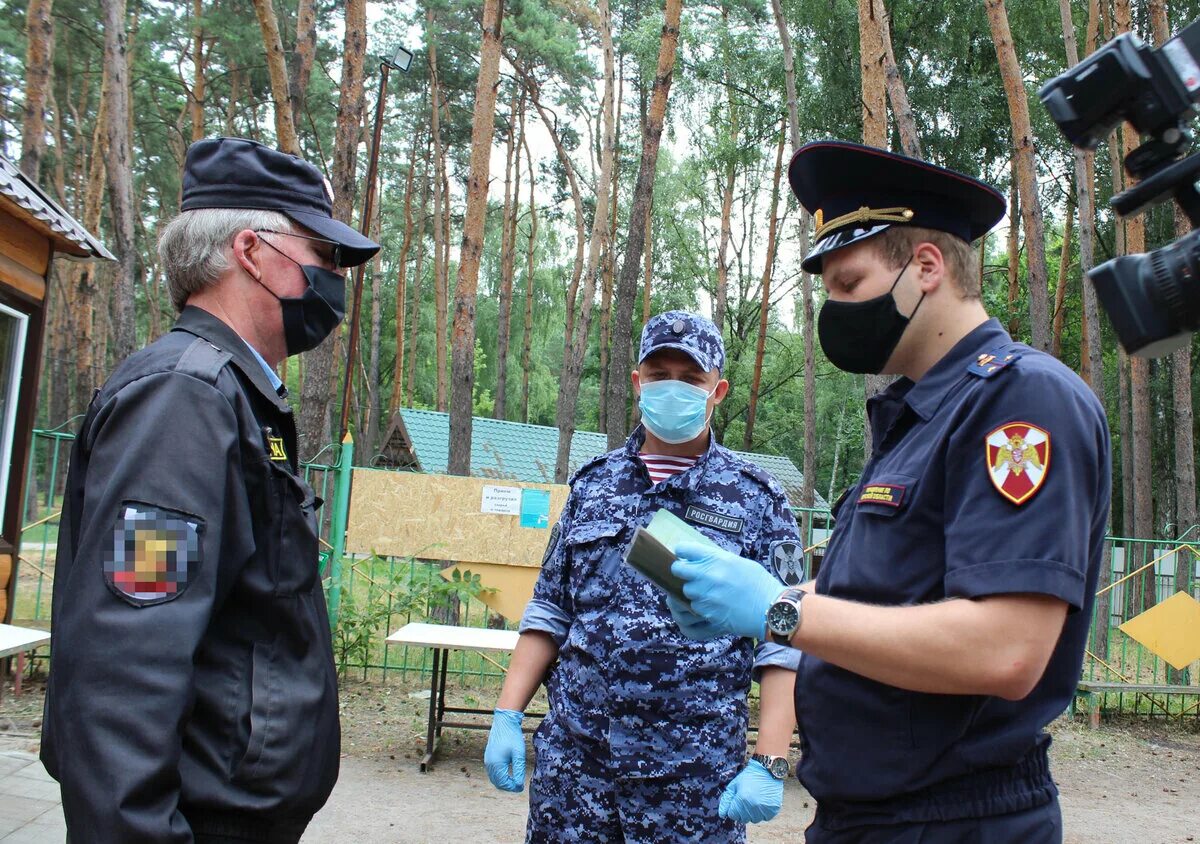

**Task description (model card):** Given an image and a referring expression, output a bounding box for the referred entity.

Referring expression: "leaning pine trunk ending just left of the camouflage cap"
[607,0,683,449]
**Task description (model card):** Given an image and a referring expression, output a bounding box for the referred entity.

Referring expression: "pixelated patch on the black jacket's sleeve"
[104,502,204,606]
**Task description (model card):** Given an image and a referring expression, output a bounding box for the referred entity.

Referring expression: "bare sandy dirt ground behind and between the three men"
[0,680,1200,844]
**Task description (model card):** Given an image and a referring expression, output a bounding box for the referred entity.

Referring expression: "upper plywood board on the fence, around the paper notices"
[346,469,570,567]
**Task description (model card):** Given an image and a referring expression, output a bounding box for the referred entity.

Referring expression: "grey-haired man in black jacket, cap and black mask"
[42,138,379,844]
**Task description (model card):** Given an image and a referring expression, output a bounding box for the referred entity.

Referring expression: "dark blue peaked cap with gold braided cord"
[787,140,1006,273]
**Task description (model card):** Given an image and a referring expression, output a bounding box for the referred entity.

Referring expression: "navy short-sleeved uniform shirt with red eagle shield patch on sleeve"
[796,319,1110,822]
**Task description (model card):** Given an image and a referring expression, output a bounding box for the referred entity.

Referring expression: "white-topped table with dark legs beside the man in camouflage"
[386,622,530,772]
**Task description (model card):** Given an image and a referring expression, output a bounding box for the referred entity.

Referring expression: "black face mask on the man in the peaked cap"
[817,258,925,375]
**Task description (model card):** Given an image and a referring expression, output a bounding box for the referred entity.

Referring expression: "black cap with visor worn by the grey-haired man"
[180,138,379,267]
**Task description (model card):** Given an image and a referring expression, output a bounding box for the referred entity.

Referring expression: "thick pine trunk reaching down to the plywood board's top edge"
[448,0,504,475]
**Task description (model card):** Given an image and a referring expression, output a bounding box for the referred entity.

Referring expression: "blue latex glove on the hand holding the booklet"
[671,543,785,639]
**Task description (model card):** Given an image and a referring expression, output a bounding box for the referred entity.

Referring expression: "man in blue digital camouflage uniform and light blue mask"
[485,311,799,844]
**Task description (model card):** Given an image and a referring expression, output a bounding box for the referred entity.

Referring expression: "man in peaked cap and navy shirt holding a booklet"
[673,140,1110,843]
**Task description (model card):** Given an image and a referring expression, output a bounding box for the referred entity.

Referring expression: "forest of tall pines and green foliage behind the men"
[0,0,1200,614]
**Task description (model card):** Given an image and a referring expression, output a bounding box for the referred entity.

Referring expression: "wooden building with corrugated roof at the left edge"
[0,156,114,622]
